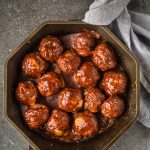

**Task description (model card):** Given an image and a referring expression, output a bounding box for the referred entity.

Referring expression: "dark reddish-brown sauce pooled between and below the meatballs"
[20,34,118,142]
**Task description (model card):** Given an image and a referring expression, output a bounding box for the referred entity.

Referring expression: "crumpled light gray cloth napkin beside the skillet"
[83,0,150,128]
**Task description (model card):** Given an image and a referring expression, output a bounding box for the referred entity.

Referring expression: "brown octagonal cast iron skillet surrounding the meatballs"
[4,21,139,150]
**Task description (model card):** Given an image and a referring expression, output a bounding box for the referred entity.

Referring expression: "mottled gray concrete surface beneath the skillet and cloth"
[0,0,150,150]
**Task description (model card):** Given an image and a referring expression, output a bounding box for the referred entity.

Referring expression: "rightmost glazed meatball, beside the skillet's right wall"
[101,71,127,95]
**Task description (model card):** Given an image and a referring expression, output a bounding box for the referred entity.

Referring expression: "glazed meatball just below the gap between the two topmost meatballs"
[57,50,81,73]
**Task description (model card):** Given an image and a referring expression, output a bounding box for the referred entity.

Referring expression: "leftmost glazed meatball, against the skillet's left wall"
[16,81,38,106]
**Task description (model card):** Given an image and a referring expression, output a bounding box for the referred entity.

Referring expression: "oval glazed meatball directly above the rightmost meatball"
[93,43,117,71]
